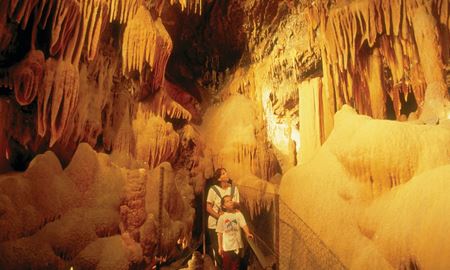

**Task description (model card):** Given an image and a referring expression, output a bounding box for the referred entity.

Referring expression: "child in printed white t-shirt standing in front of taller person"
[216,195,253,270]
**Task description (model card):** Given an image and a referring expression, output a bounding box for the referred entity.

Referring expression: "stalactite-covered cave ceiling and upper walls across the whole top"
[0,0,449,173]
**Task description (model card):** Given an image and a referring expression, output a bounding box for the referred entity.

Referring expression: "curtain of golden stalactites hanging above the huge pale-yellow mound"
[308,0,449,119]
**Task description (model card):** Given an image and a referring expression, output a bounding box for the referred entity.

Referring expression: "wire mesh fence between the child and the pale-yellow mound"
[224,186,346,270]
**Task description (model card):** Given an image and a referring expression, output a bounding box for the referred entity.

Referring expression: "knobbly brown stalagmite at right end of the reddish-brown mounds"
[140,162,194,259]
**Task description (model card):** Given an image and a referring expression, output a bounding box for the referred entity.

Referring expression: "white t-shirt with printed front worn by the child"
[216,212,247,251]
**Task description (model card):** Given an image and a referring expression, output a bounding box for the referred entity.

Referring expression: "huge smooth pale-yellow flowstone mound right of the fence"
[280,106,450,269]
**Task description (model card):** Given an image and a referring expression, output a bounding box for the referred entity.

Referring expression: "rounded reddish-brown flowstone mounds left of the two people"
[0,144,194,269]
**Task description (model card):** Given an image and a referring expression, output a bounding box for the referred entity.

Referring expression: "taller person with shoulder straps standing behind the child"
[206,168,239,268]
